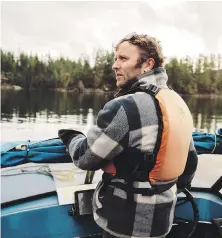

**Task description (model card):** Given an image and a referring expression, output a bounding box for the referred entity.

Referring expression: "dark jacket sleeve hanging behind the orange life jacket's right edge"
[177,138,198,189]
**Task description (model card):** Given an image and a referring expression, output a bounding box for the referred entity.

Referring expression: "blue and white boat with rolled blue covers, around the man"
[1,133,222,238]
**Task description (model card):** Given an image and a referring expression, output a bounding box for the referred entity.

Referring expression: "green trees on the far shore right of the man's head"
[166,55,222,94]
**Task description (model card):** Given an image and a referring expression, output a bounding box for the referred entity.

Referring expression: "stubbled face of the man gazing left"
[112,41,141,88]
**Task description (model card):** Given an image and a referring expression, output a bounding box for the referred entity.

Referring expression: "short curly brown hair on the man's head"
[114,32,164,68]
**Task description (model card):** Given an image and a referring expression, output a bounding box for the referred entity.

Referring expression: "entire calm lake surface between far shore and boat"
[1,90,222,141]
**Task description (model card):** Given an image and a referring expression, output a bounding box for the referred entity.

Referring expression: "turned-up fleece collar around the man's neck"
[114,67,168,98]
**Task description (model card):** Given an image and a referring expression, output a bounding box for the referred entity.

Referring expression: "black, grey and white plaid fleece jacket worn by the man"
[60,68,196,238]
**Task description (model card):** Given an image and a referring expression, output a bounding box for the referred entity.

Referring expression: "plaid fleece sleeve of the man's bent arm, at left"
[60,99,129,170]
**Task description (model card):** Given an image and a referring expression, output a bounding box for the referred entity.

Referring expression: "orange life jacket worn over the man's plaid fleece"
[100,85,193,183]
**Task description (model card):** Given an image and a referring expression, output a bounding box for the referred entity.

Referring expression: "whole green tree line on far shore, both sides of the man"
[1,50,222,94]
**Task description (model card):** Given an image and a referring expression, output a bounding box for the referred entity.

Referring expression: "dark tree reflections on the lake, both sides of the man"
[1,91,222,132]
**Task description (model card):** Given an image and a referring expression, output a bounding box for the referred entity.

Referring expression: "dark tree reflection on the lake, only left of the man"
[1,91,113,124]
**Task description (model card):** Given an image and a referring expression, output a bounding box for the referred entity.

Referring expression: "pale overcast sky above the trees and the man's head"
[1,1,222,63]
